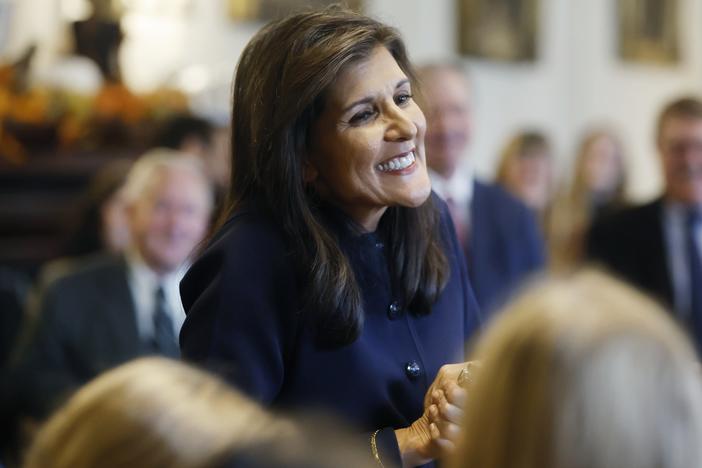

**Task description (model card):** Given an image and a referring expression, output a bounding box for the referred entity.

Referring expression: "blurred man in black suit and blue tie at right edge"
[587,97,702,350]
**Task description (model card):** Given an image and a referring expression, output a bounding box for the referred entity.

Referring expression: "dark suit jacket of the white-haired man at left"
[15,252,142,411]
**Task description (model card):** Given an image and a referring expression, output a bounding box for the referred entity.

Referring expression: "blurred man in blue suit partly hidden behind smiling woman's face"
[420,64,544,313]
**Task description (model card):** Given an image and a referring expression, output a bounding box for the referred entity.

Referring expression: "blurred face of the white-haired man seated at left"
[129,168,211,274]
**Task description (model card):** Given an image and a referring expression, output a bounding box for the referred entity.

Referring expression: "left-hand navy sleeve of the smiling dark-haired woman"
[180,221,298,403]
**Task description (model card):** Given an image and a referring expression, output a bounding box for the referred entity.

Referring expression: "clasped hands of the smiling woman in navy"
[395,364,466,467]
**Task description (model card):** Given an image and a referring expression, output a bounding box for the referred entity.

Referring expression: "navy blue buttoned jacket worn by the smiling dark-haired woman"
[180,196,480,460]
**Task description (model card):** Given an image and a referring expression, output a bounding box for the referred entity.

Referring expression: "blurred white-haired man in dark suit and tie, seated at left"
[13,150,212,417]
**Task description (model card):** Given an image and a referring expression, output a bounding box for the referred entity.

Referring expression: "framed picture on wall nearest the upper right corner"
[617,0,680,65]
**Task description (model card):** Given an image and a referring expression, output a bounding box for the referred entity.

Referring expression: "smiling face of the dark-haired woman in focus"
[305,46,431,231]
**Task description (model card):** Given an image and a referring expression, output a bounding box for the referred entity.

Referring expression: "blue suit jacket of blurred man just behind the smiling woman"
[465,181,545,314]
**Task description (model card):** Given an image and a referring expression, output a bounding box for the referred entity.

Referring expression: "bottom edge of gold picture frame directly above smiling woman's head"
[226,0,363,21]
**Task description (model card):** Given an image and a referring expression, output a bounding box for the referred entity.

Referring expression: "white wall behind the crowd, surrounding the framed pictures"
[0,0,702,199]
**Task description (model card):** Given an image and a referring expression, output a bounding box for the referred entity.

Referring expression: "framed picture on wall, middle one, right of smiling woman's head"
[457,0,541,62]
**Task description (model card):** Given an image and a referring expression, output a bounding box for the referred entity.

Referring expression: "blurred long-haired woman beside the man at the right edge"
[547,130,626,271]
